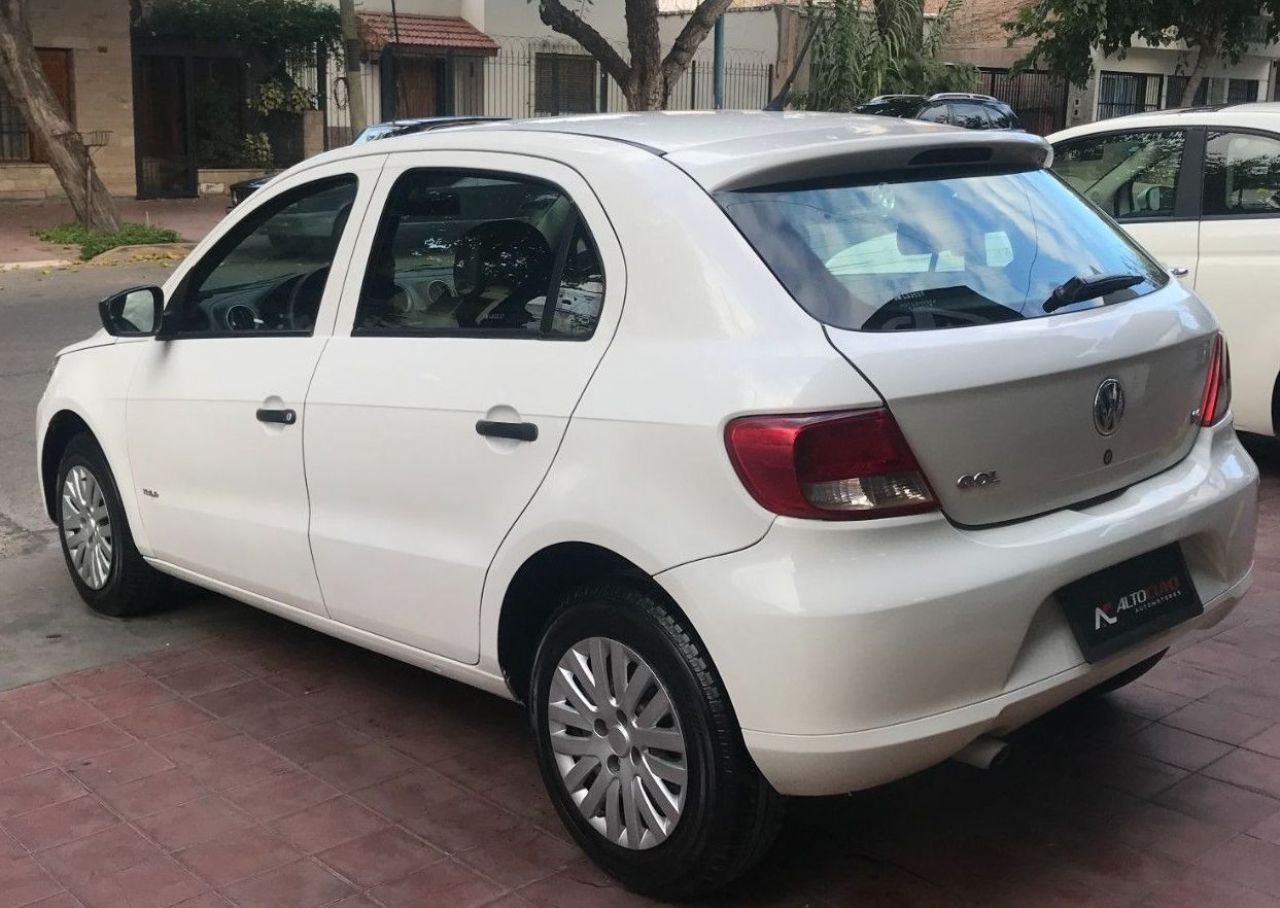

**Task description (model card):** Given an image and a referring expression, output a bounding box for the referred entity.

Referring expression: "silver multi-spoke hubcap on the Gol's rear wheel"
[547,636,689,849]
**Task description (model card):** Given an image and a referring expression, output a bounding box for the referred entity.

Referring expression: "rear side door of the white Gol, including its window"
[306,151,623,662]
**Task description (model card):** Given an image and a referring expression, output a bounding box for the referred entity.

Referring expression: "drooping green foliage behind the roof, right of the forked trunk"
[795,0,978,110]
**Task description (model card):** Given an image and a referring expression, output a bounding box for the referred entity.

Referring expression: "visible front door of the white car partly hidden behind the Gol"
[1053,128,1202,287]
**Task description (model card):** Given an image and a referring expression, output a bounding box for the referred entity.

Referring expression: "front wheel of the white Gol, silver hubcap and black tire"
[55,433,172,617]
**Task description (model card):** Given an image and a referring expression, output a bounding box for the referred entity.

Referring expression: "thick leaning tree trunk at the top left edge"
[0,0,120,231]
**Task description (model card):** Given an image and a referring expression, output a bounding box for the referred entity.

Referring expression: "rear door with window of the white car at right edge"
[1196,129,1280,435]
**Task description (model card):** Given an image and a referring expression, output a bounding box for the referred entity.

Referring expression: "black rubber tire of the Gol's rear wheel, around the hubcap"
[529,581,783,900]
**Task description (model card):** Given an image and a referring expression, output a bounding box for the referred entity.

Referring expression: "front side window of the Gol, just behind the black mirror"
[165,175,356,337]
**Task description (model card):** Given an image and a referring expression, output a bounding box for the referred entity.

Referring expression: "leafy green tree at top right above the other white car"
[1005,0,1280,106]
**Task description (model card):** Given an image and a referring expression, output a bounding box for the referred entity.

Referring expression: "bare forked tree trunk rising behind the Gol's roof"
[530,0,732,110]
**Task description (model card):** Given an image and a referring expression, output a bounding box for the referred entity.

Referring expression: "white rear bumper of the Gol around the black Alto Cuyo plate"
[658,421,1257,794]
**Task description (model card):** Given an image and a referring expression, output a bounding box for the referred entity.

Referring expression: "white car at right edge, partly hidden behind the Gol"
[1050,102,1280,435]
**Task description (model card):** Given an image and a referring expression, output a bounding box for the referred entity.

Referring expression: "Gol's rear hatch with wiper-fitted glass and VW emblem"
[717,162,1215,525]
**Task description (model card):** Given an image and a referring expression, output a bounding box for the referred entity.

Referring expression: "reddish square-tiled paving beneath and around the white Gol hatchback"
[0,479,1280,908]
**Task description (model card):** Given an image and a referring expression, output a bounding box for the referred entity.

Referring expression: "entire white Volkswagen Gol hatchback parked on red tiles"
[38,113,1257,896]
